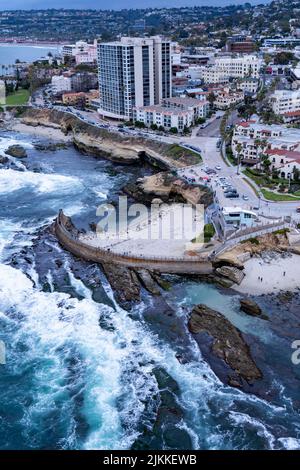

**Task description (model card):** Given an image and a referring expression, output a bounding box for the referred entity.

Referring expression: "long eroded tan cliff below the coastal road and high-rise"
[21,108,201,169]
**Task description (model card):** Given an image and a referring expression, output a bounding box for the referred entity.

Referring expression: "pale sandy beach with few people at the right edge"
[234,254,300,295]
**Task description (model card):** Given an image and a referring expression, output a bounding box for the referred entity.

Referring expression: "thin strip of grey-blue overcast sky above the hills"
[0,0,268,10]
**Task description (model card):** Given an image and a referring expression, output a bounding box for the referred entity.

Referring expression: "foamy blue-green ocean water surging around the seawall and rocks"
[0,133,300,449]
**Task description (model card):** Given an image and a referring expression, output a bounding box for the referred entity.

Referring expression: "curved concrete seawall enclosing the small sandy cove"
[54,210,213,274]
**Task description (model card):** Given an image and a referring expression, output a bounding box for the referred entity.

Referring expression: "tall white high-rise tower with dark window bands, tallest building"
[98,36,171,120]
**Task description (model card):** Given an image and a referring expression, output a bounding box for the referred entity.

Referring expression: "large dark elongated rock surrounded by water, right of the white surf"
[188,305,262,385]
